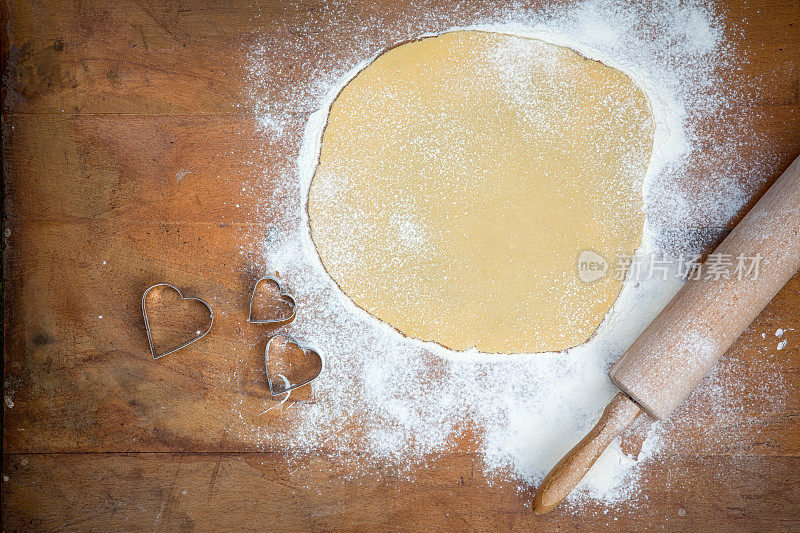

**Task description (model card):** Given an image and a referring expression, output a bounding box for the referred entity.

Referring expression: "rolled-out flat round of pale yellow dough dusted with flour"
[308,31,653,353]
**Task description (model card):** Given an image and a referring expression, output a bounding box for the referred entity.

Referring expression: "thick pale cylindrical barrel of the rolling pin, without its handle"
[609,158,800,419]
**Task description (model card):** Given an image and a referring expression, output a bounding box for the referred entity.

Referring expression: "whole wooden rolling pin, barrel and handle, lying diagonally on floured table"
[533,157,800,514]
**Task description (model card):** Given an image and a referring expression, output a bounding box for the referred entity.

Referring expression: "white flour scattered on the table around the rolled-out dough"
[238,0,782,507]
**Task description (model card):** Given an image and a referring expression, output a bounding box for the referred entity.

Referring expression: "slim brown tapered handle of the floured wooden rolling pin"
[533,392,642,514]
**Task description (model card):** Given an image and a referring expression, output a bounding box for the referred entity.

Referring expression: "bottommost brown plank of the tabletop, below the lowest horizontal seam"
[3,453,800,532]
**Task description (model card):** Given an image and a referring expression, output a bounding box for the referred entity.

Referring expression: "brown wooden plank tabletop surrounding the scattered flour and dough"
[2,0,800,531]
